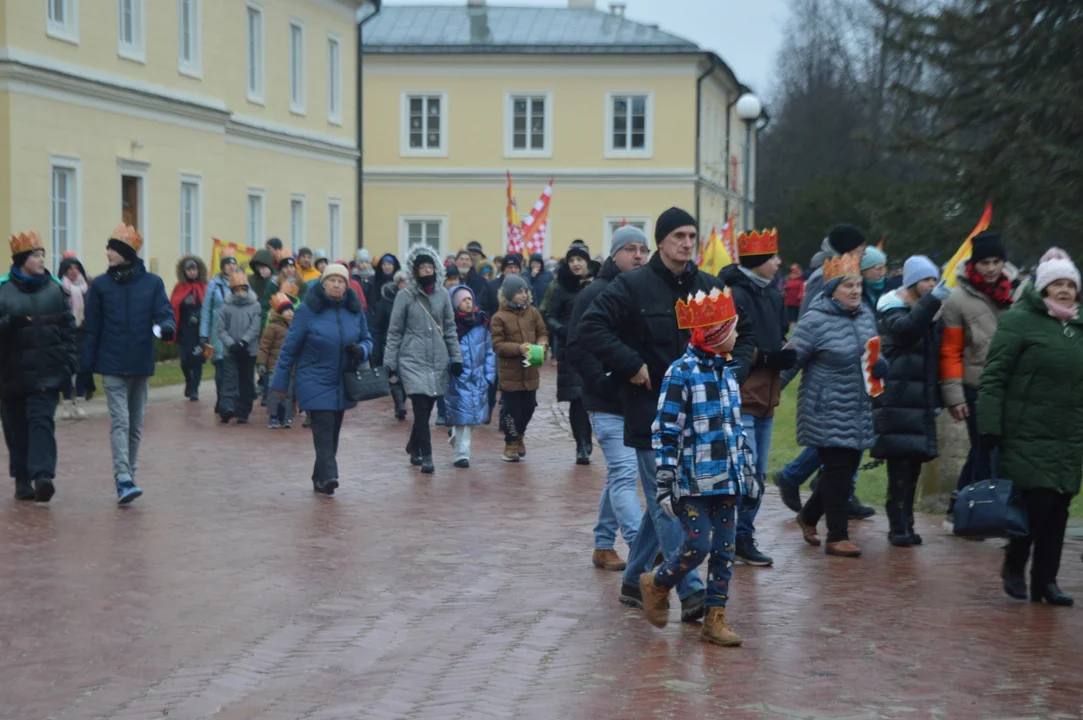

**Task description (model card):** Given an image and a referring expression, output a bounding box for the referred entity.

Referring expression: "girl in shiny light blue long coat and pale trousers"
[444,285,496,468]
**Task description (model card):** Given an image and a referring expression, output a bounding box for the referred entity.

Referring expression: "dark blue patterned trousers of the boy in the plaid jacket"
[654,495,740,607]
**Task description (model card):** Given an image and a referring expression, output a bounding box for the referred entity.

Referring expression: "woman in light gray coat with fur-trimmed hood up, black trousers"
[383,245,462,474]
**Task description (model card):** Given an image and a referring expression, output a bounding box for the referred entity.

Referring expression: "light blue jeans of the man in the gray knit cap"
[589,413,643,550]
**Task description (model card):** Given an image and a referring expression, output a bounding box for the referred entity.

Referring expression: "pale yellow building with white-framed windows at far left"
[0,0,372,277]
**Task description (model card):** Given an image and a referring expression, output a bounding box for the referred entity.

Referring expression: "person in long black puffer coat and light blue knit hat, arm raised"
[872,256,951,541]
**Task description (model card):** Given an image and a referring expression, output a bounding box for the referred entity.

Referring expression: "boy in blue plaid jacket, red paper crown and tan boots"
[639,289,759,645]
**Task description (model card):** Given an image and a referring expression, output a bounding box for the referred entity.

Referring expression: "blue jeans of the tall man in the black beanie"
[624,449,703,600]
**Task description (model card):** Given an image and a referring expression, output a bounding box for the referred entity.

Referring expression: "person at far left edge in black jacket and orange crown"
[0,231,77,502]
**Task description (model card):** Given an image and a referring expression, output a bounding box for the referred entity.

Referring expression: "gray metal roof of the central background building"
[363,4,704,54]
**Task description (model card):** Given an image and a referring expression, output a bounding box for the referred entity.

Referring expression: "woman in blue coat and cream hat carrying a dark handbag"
[271,263,373,495]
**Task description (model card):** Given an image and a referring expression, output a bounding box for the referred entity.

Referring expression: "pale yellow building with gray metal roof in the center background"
[362,0,755,257]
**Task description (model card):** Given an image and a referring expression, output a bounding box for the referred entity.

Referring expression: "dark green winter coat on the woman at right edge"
[978,284,1083,495]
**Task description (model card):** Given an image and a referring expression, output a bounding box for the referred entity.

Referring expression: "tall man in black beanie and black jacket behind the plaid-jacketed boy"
[578,208,755,621]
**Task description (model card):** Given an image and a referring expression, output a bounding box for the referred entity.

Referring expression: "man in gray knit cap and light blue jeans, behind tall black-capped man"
[564,225,651,571]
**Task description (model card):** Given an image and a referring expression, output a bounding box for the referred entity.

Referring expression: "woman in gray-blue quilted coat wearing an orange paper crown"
[782,256,887,558]
